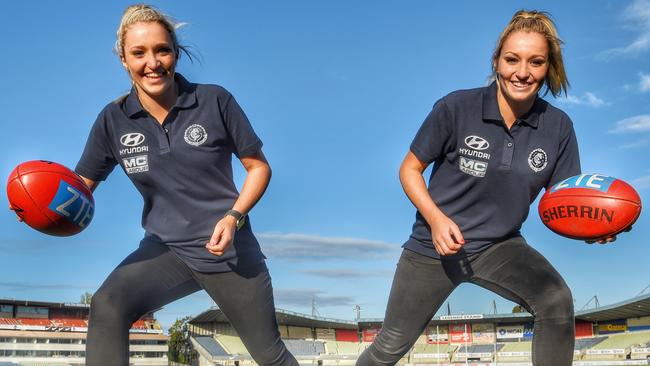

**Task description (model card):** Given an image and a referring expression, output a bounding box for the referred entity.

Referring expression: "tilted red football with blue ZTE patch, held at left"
[7,160,95,236]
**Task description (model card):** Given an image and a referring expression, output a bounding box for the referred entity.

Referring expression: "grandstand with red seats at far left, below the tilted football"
[0,299,168,366]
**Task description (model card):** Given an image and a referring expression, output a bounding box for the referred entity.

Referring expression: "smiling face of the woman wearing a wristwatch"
[122,22,177,99]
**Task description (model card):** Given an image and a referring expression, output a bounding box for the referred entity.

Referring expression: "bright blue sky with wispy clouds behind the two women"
[0,0,650,327]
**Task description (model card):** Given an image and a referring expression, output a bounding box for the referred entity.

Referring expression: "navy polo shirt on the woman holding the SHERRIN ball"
[404,83,580,258]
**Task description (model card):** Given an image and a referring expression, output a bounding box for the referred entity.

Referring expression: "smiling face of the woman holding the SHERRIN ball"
[495,31,549,109]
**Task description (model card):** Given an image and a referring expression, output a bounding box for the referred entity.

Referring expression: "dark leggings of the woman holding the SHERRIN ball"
[357,237,575,366]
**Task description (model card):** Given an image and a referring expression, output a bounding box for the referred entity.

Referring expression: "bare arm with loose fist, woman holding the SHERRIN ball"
[399,151,465,255]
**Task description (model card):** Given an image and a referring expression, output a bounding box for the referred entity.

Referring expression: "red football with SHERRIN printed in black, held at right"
[538,174,641,240]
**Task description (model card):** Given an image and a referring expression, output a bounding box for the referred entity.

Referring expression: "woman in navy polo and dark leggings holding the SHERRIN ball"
[357,11,613,366]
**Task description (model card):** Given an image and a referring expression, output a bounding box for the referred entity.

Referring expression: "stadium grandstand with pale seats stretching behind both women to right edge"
[188,294,650,366]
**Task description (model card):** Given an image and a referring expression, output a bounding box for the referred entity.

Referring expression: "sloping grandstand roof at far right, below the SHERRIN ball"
[576,294,650,322]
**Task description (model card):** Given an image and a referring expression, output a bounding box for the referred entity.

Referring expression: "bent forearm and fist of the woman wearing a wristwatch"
[205,150,271,256]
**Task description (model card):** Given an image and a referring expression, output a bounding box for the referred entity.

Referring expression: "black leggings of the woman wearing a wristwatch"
[86,241,298,366]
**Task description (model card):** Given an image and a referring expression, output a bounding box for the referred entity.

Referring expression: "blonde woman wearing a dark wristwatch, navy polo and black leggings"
[76,5,298,366]
